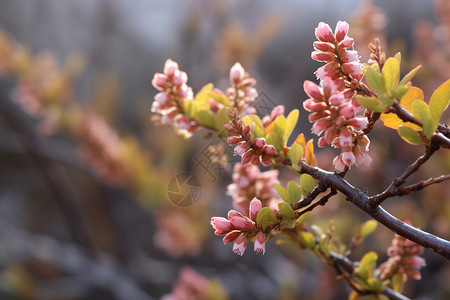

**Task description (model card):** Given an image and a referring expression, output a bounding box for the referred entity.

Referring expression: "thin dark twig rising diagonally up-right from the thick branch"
[369,143,439,208]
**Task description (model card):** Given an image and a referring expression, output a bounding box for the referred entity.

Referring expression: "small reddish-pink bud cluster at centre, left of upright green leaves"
[224,112,277,166]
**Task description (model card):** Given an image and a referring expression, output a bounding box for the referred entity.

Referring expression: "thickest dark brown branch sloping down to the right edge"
[301,162,450,259]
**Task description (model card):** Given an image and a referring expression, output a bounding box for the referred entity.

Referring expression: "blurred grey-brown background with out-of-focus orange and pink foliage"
[0,0,450,299]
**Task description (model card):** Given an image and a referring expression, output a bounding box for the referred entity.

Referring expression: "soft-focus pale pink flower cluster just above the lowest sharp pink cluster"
[227,163,279,214]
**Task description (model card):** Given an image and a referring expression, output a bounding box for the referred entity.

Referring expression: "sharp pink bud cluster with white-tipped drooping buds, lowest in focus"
[211,197,267,255]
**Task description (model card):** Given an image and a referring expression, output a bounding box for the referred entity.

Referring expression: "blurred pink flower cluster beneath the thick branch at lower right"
[380,221,426,280]
